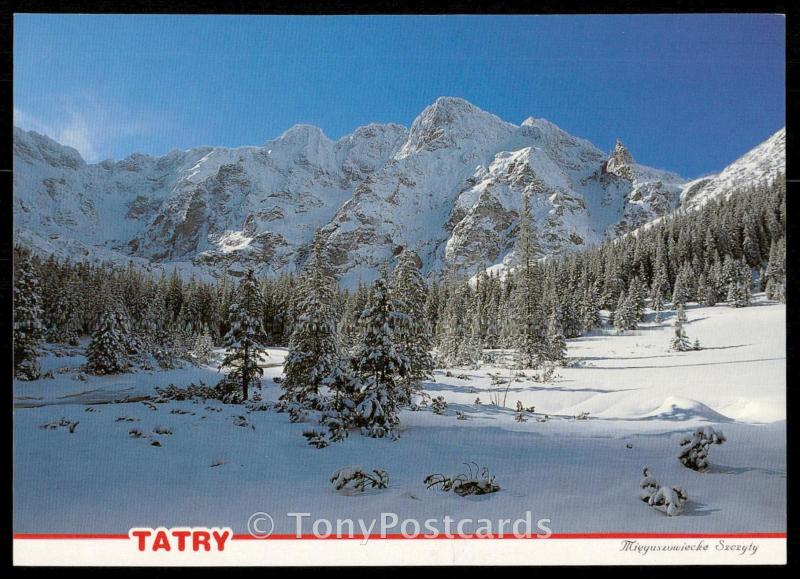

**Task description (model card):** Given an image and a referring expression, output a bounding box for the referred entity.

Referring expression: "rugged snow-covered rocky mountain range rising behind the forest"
[14,97,785,285]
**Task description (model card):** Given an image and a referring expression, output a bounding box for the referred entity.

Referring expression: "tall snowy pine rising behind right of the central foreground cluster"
[390,249,434,404]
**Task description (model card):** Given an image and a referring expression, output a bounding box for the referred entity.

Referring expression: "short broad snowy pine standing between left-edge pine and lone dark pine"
[86,304,131,375]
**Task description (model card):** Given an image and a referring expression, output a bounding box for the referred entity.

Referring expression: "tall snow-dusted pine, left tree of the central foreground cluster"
[280,238,339,408]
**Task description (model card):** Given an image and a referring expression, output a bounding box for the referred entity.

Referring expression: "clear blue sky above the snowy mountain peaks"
[14,15,785,177]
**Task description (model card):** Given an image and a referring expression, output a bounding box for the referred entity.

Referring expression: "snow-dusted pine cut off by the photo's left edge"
[14,255,44,380]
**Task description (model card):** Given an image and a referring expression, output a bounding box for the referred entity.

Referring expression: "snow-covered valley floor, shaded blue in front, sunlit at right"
[14,298,786,533]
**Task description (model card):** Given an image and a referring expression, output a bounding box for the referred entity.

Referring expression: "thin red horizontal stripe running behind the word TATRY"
[14,533,786,541]
